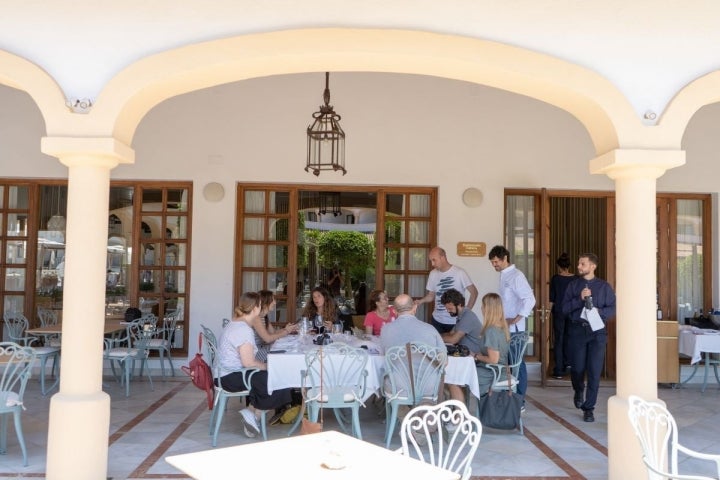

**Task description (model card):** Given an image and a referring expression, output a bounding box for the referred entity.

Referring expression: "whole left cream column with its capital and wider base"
[42,137,134,480]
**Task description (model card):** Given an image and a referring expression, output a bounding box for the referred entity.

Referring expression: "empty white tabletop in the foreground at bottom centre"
[165,431,460,480]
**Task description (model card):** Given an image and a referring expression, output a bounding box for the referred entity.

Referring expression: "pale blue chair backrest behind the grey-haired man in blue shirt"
[385,343,447,405]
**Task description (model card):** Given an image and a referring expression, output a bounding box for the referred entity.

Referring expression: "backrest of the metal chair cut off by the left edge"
[0,342,35,412]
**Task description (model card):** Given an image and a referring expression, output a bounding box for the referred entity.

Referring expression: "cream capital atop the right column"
[590,148,685,180]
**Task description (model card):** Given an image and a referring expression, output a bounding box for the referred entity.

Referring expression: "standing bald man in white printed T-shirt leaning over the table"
[415,247,478,334]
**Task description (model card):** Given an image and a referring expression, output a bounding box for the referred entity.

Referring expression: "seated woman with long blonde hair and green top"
[475,293,510,395]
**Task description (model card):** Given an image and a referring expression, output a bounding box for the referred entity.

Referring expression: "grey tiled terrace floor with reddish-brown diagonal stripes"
[0,376,720,479]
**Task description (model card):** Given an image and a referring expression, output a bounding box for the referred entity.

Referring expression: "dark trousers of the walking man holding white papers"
[568,322,607,410]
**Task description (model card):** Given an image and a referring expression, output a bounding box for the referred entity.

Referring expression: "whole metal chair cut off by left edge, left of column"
[0,342,36,467]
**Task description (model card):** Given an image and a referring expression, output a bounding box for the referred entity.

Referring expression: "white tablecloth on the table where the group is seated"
[268,336,480,400]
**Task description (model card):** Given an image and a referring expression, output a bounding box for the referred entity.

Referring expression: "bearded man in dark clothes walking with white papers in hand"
[563,253,615,422]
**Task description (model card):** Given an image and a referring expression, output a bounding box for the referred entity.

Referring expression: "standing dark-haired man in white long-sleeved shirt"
[488,245,535,408]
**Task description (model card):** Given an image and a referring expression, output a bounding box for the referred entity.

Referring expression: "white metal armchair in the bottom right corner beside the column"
[628,395,720,480]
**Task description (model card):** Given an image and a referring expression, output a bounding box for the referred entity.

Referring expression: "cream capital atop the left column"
[40,137,135,168]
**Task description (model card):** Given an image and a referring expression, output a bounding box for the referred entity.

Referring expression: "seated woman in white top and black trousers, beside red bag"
[218,292,291,438]
